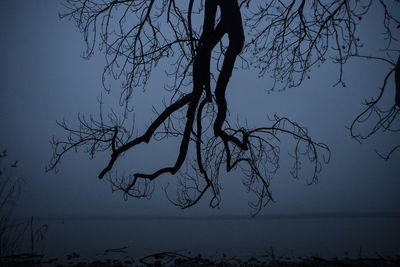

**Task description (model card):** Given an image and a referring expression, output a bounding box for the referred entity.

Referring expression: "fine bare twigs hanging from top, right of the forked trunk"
[246,0,372,89]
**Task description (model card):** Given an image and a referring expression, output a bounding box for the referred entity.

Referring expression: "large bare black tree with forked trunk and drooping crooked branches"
[48,0,398,214]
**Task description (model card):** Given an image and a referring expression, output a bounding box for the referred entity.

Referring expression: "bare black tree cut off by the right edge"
[349,0,400,160]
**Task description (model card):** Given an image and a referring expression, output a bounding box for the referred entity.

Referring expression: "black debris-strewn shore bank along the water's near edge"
[0,252,400,267]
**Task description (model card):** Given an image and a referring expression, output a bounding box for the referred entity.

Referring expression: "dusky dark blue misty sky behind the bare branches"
[0,0,400,219]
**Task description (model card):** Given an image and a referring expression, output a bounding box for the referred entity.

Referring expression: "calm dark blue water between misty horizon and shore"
[37,216,400,259]
